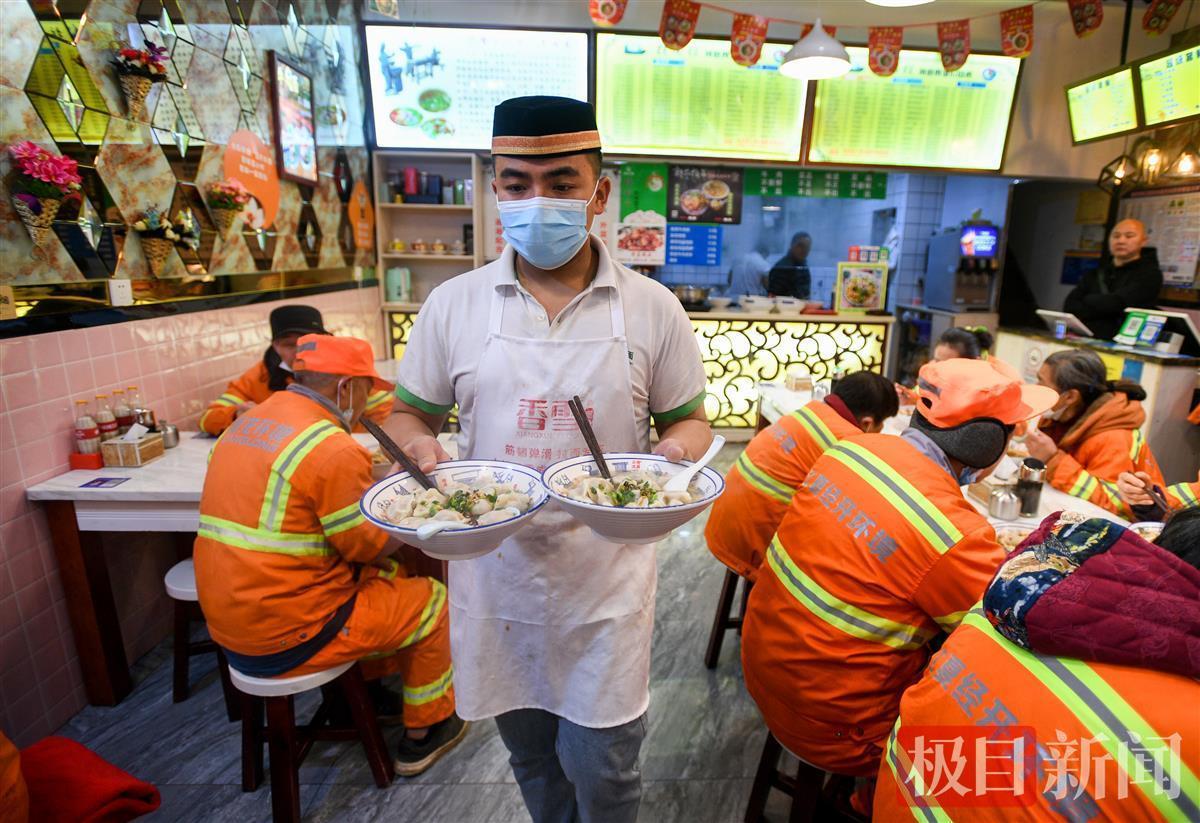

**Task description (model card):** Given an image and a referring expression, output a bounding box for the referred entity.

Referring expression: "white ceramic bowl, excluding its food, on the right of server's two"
[541,452,725,543]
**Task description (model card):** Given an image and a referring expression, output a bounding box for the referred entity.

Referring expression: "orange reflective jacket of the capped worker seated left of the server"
[194,391,388,655]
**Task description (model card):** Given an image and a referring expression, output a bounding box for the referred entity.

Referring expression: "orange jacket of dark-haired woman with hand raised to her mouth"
[1046,392,1166,518]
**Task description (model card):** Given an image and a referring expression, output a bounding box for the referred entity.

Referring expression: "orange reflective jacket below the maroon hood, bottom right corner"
[872,611,1200,823]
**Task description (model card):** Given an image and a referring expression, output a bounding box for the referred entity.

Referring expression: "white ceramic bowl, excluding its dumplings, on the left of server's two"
[359,459,547,560]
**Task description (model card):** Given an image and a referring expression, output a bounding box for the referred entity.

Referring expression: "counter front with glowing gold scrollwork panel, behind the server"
[383,304,895,431]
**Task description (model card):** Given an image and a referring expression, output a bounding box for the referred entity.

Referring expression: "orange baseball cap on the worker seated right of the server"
[917,358,1058,428]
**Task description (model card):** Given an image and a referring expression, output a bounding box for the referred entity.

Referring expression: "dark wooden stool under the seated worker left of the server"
[229,663,395,823]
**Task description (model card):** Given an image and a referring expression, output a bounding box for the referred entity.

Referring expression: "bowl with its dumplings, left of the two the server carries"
[359,459,547,560]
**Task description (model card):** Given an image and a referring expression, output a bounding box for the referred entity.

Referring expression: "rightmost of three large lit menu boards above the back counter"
[808,48,1021,172]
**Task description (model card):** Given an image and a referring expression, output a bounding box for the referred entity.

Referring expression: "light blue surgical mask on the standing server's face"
[496,181,600,270]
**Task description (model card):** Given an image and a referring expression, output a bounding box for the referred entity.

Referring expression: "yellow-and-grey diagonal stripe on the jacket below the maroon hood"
[962,611,1200,821]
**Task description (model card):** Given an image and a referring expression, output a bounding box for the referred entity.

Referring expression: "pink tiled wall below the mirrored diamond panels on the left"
[0,289,384,745]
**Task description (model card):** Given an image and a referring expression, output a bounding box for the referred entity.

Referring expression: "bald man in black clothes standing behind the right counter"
[1062,220,1163,340]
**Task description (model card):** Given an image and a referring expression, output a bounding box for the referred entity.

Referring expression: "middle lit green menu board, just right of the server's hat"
[596,32,808,162]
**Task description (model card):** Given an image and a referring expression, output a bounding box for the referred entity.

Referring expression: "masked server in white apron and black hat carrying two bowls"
[389,97,712,823]
